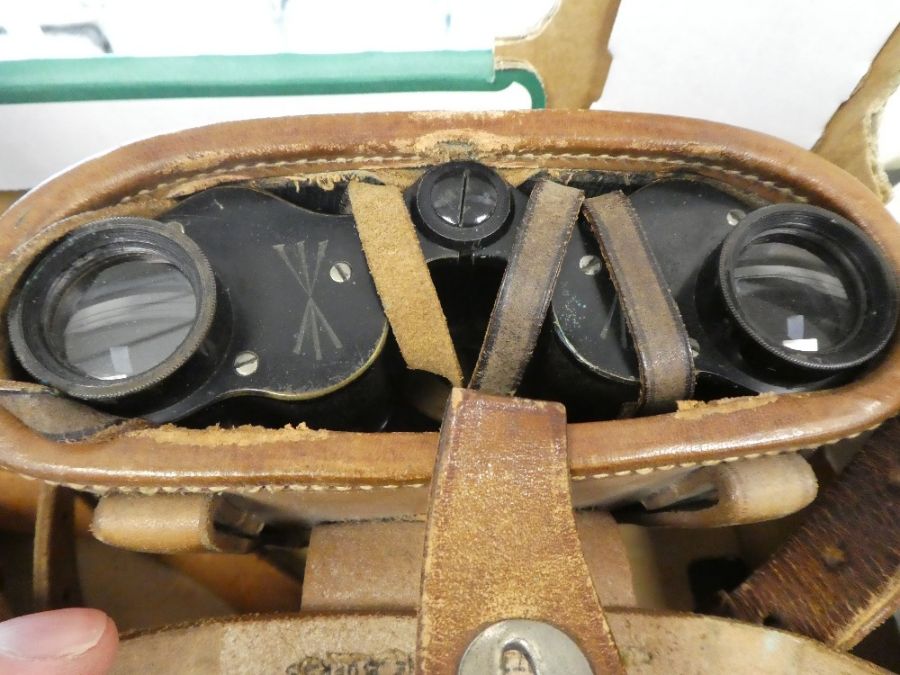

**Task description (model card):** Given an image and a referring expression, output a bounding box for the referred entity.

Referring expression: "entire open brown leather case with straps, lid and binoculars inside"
[0,111,900,673]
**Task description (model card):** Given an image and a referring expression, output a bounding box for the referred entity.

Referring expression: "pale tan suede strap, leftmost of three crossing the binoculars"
[347,182,462,386]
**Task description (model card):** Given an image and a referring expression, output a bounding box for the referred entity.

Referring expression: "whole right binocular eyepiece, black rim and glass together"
[719,204,897,371]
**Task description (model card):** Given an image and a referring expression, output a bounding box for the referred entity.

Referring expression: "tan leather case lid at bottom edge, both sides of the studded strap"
[111,610,888,675]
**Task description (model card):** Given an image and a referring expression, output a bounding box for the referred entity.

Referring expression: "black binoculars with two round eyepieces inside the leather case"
[7,162,898,430]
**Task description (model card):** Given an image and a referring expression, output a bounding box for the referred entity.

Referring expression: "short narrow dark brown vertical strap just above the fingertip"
[32,483,81,612]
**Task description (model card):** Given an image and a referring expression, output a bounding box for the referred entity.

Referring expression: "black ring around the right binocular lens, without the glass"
[718,204,898,371]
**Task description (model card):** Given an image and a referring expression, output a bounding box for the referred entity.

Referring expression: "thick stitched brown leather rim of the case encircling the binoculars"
[0,111,900,520]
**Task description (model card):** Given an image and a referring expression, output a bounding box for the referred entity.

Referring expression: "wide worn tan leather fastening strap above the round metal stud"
[416,389,624,674]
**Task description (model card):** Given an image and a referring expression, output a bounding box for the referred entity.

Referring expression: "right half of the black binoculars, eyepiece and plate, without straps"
[536,179,897,419]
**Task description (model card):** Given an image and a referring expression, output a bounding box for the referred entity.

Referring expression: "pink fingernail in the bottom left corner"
[0,607,107,660]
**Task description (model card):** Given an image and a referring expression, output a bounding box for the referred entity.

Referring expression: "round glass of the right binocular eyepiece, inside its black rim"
[733,241,864,352]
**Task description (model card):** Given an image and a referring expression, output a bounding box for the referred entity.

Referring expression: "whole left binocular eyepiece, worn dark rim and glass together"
[9,218,216,400]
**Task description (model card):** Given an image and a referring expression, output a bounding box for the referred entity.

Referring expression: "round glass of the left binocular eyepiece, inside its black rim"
[50,256,197,380]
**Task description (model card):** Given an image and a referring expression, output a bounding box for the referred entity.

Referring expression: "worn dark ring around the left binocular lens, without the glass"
[9,217,216,400]
